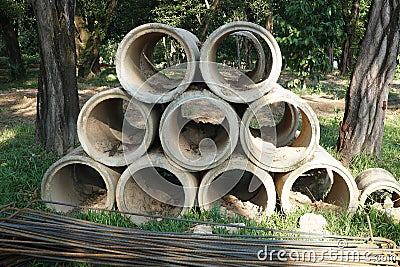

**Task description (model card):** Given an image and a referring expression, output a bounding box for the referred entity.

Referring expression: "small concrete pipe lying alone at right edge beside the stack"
[356,168,400,208]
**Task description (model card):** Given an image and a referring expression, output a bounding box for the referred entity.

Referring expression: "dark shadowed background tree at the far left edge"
[0,0,25,79]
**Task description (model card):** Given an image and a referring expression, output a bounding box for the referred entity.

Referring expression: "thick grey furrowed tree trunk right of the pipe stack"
[337,0,400,158]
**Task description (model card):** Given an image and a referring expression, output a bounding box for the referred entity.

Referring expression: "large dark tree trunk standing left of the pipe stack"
[32,0,79,155]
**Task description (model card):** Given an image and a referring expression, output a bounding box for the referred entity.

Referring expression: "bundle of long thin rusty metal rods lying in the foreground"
[0,203,400,266]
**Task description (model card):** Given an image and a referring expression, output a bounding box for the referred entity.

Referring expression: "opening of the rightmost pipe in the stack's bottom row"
[289,168,351,210]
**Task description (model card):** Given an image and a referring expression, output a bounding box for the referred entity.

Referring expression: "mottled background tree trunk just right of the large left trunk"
[74,0,117,78]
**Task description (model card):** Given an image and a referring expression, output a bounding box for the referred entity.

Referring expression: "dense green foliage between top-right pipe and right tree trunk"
[274,0,344,77]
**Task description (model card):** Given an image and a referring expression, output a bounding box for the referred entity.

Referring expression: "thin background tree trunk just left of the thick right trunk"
[340,0,360,76]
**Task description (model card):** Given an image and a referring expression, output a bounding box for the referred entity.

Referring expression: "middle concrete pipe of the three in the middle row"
[159,90,239,171]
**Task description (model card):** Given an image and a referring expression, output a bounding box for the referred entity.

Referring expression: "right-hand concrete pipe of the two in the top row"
[200,21,282,103]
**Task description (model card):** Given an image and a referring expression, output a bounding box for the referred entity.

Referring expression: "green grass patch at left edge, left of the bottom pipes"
[0,124,57,205]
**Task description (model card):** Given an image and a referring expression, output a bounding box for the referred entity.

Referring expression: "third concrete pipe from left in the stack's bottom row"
[198,153,276,219]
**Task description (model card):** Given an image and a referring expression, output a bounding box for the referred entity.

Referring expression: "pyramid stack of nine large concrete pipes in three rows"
[42,22,396,224]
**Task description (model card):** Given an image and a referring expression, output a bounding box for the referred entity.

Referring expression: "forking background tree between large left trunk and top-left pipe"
[74,0,117,78]
